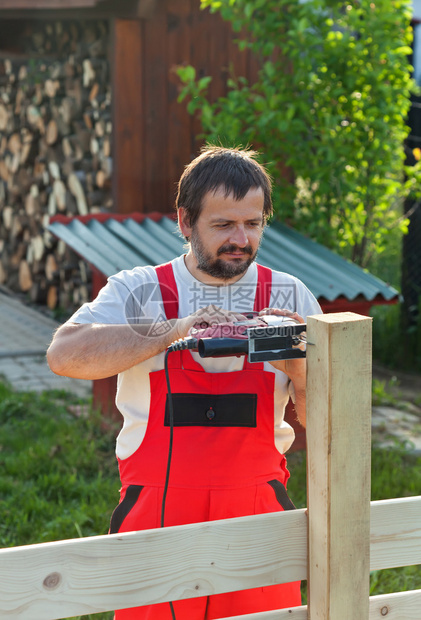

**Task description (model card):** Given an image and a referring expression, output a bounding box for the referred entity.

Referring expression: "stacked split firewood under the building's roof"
[0,22,112,310]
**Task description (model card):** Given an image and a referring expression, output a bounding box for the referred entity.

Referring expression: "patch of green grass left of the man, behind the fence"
[0,383,119,620]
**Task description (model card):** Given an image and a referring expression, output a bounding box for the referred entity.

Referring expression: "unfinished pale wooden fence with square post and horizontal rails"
[0,313,421,620]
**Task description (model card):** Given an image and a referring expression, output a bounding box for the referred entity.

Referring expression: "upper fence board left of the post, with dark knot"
[0,510,307,620]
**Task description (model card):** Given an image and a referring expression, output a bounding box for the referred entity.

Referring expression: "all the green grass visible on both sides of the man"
[0,383,421,620]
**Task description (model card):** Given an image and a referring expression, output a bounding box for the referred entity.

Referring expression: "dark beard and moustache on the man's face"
[190,228,257,280]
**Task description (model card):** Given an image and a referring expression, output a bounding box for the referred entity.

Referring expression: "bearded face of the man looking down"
[179,188,264,281]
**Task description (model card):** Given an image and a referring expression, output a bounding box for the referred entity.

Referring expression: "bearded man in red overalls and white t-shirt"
[47,146,320,620]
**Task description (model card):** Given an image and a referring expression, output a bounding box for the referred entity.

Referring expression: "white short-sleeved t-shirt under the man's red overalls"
[69,256,321,459]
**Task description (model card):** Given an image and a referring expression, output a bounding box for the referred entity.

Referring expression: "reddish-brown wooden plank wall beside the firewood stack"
[113,0,257,218]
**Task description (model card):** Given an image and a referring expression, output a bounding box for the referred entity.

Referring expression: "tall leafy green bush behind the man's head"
[178,0,421,266]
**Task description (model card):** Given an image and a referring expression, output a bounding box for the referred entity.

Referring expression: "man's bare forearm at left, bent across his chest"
[47,320,179,379]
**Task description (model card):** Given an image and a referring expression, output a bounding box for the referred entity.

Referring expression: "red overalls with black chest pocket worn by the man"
[110,264,301,620]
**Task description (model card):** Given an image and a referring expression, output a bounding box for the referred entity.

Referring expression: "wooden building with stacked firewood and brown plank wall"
[0,0,257,309]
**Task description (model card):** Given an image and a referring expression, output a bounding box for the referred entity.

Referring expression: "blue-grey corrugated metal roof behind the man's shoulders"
[49,214,399,302]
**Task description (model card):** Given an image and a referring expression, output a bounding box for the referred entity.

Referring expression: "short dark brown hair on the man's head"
[175,144,273,226]
